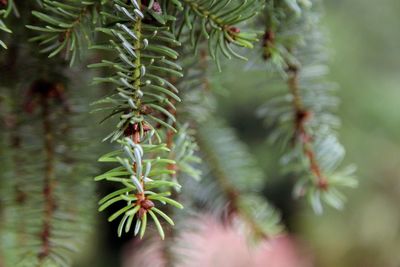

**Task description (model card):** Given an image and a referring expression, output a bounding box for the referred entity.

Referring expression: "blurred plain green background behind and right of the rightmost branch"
[221,0,400,267]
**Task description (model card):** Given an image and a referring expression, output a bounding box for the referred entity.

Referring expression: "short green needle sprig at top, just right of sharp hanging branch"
[171,0,263,70]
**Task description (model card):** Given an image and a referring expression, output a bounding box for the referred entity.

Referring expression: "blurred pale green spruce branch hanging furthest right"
[259,1,356,213]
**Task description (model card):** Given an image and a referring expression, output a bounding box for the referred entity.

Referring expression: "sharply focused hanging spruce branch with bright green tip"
[94,0,183,238]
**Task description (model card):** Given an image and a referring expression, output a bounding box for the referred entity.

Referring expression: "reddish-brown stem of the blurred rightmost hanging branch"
[287,65,329,190]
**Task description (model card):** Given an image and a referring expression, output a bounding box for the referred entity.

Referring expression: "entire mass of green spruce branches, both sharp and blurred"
[0,0,356,267]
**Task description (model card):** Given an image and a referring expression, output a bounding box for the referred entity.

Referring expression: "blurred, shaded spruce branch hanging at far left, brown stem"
[1,72,97,267]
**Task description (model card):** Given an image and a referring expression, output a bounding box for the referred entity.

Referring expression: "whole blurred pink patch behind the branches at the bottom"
[124,217,313,267]
